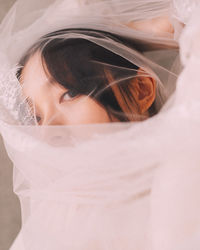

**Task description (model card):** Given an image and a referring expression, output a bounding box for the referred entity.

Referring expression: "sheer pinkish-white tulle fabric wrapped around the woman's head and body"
[0,1,200,250]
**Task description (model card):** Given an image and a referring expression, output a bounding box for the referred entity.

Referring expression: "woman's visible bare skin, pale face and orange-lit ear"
[21,53,155,125]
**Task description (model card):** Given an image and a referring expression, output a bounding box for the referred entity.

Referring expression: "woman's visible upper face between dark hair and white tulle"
[21,53,113,125]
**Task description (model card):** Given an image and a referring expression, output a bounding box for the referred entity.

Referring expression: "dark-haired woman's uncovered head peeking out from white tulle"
[17,29,175,125]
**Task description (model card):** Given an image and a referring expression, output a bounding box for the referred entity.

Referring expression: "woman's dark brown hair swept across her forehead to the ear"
[17,29,157,121]
